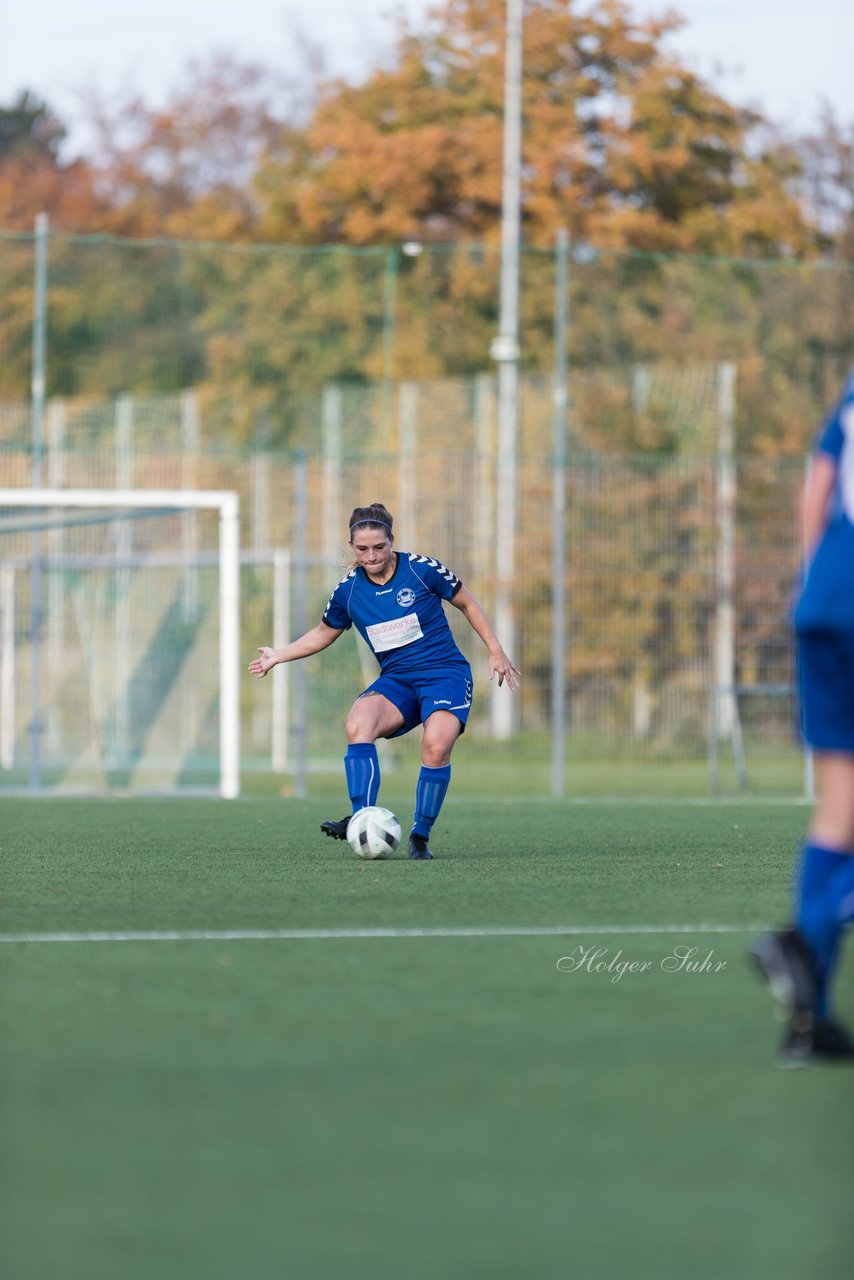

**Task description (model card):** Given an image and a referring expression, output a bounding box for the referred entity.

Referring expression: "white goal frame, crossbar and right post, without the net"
[0,488,241,799]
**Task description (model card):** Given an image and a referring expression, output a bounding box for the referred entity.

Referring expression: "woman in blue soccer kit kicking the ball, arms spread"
[243,502,520,858]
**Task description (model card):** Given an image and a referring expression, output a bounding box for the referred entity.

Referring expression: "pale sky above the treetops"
[0,0,854,150]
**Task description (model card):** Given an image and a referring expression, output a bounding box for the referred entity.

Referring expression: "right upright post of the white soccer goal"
[219,493,241,800]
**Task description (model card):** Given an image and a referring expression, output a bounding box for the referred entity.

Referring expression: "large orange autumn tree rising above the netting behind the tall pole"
[255,0,813,255]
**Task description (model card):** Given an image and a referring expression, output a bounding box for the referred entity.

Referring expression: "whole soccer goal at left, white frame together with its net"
[0,489,239,799]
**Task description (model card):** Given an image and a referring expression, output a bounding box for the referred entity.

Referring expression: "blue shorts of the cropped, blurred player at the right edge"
[798,631,854,754]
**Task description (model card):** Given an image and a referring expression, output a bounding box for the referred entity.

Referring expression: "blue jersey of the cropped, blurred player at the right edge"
[795,370,854,631]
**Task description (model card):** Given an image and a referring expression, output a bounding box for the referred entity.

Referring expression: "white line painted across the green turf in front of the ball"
[0,924,767,942]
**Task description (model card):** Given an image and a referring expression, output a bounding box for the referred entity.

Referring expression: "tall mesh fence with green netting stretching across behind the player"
[0,225,854,795]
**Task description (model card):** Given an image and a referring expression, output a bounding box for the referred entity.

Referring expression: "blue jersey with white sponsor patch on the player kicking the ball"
[323,552,466,675]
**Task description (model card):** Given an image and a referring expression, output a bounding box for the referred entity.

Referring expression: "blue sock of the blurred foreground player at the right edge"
[795,845,854,1019]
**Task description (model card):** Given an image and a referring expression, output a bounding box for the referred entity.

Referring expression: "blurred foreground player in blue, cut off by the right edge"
[750,370,854,1065]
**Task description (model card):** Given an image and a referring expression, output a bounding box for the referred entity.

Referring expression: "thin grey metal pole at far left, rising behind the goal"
[29,214,50,791]
